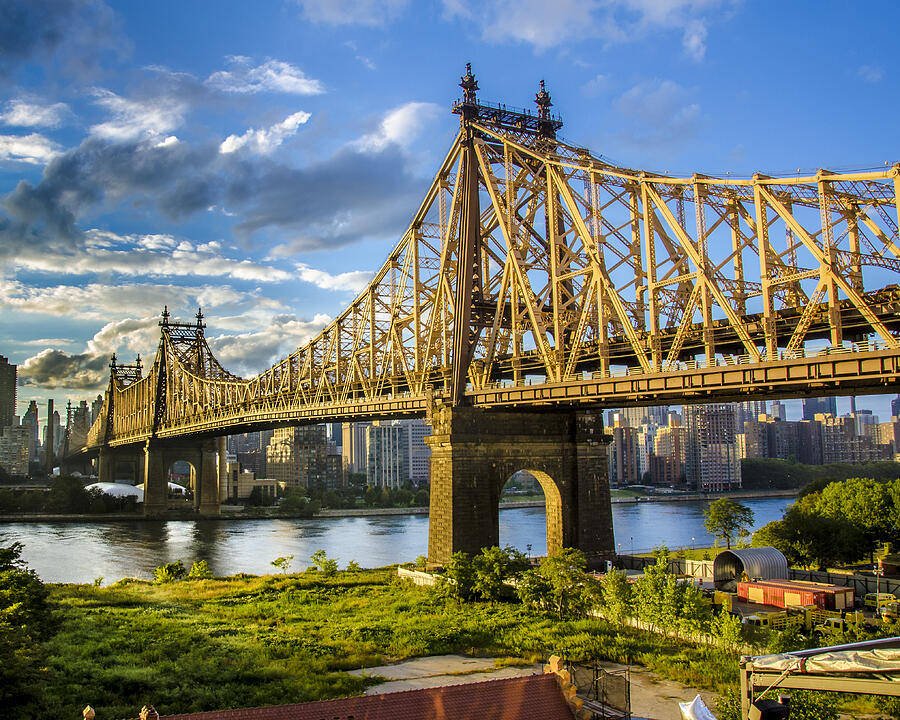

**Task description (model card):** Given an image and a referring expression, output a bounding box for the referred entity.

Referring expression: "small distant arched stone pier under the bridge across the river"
[143,438,224,516]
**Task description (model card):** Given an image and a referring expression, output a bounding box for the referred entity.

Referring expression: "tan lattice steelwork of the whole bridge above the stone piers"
[74,66,900,445]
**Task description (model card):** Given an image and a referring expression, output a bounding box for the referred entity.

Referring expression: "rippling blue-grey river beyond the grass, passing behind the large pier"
[0,498,793,584]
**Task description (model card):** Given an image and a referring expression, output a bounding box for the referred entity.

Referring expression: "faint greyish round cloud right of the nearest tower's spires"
[613,80,700,147]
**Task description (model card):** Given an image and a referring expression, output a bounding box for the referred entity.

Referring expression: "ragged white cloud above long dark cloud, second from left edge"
[91,88,187,140]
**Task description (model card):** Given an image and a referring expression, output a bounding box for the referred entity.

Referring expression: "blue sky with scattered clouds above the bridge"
[0,0,900,422]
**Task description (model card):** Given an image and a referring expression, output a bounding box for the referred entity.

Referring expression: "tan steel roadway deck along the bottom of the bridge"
[93,349,900,450]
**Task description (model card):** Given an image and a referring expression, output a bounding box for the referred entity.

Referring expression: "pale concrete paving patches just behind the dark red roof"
[351,655,715,720]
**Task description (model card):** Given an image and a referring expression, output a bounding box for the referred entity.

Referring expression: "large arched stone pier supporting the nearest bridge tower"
[426,402,615,567]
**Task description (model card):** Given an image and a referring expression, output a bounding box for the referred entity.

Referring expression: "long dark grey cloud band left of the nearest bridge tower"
[0,129,424,262]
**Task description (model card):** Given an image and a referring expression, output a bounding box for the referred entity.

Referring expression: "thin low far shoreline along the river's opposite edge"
[0,490,799,524]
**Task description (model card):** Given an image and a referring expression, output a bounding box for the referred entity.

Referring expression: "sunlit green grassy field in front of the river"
[41,569,737,718]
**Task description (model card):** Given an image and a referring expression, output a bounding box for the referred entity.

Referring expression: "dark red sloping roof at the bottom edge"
[134,673,574,720]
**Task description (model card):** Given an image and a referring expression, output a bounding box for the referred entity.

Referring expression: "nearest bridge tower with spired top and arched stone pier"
[426,64,615,566]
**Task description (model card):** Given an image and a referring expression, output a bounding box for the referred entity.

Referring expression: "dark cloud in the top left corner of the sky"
[0,0,123,80]
